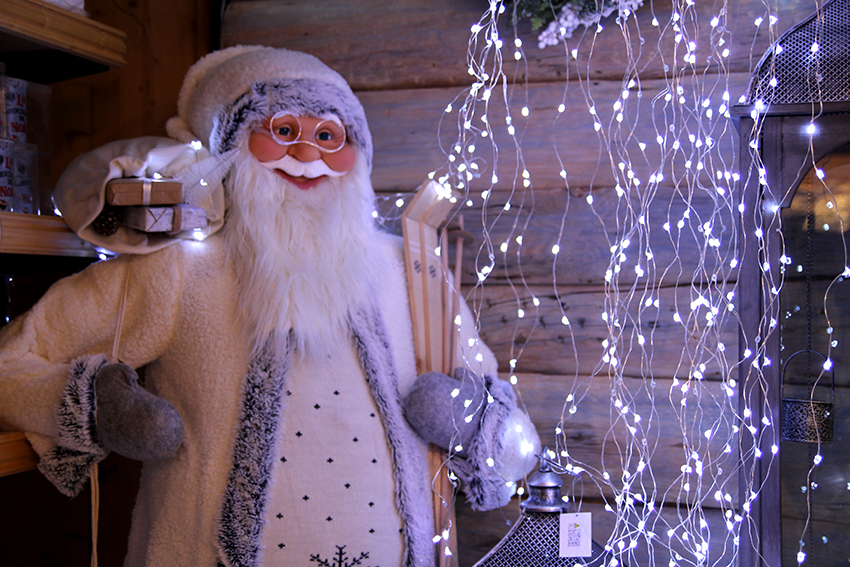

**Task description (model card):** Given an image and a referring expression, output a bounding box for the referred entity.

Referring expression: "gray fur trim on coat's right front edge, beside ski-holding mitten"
[350,306,435,567]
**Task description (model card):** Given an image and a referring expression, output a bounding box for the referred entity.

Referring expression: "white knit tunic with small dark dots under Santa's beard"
[262,339,403,567]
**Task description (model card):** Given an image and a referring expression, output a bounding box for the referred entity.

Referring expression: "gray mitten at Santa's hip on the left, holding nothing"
[95,364,183,461]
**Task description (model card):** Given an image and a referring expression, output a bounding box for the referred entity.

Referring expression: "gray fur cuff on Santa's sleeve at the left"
[38,355,107,496]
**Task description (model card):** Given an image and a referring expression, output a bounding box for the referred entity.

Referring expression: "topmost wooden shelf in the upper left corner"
[0,0,127,84]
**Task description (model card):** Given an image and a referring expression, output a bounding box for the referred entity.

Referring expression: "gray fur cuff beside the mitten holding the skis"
[449,376,517,511]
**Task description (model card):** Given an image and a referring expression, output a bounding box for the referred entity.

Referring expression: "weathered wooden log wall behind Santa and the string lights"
[222,0,828,565]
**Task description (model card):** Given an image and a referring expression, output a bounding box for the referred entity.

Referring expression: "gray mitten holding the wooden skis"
[404,368,487,457]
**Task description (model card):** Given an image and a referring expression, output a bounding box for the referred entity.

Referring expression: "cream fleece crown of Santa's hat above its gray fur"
[166,46,371,162]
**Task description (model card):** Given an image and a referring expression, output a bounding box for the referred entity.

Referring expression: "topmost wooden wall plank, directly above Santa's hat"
[221,0,813,90]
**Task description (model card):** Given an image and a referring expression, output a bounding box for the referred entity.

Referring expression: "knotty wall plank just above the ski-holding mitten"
[468,285,738,380]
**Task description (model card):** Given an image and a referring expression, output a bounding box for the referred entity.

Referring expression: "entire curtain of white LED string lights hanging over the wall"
[372,0,850,566]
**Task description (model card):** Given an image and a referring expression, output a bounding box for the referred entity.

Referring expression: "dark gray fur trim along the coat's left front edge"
[218,337,295,567]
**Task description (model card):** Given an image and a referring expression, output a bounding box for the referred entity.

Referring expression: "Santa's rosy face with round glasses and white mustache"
[248,112,356,191]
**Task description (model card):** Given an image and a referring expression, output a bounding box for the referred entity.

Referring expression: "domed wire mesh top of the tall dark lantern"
[747,0,850,104]
